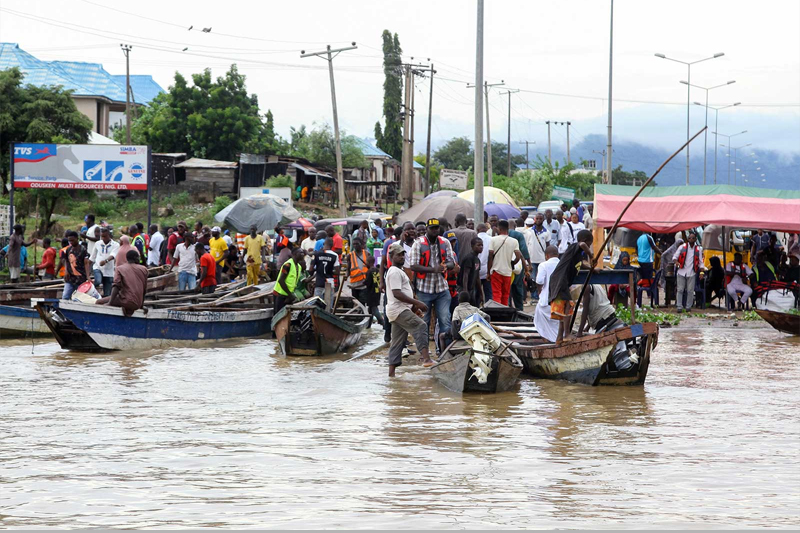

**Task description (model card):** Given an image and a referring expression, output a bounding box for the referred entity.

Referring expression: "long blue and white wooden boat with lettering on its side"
[36,280,272,351]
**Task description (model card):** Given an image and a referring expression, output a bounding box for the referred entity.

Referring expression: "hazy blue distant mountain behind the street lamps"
[512,135,800,190]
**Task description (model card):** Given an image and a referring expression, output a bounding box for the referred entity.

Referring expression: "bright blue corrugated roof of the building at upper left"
[0,43,163,104]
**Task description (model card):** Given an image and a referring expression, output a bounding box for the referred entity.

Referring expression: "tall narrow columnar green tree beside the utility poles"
[375,30,403,161]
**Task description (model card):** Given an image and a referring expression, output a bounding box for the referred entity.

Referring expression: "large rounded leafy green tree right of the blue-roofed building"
[115,64,264,160]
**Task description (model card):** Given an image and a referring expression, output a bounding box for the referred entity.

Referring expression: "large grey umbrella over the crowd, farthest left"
[214,194,300,233]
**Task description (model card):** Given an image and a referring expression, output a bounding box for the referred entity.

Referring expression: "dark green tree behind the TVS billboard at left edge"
[0,68,92,235]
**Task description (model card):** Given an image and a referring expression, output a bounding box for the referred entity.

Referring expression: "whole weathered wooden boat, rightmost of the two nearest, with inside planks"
[483,307,659,385]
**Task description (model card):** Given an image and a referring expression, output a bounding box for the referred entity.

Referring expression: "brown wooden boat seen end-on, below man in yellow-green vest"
[272,296,372,357]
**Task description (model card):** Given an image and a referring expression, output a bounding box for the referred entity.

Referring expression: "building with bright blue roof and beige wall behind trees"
[0,43,164,136]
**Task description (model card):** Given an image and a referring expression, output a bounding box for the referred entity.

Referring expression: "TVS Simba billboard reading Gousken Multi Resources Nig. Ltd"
[14,143,150,191]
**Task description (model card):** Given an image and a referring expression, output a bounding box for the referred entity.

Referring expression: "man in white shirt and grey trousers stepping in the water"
[386,241,434,377]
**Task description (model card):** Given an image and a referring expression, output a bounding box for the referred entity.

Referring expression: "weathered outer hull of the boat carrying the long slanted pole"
[515,323,658,385]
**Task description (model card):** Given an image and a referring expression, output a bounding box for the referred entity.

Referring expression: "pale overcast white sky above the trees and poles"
[6,0,800,151]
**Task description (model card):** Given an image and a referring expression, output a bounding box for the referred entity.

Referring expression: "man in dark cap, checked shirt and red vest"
[409,218,456,350]
